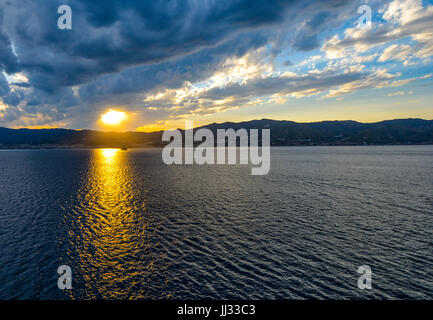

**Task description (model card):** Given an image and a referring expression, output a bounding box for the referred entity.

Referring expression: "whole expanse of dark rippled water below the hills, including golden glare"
[0,146,433,299]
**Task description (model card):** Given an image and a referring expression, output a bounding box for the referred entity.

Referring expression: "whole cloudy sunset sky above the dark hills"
[0,0,433,131]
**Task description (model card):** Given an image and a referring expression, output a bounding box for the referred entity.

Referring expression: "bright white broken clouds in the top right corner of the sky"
[322,0,433,64]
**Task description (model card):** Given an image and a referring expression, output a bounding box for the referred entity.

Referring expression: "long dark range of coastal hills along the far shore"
[0,119,433,149]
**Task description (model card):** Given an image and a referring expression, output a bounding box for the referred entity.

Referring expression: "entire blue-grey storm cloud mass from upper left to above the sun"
[0,0,370,126]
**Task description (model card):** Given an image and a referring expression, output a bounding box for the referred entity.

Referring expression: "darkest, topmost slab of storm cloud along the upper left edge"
[0,0,294,91]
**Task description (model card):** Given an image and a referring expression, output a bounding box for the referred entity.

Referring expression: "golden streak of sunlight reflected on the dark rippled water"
[68,149,168,299]
